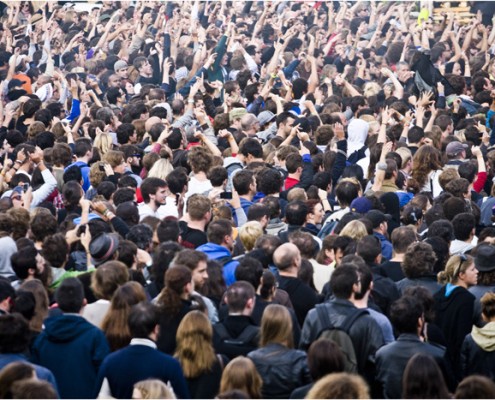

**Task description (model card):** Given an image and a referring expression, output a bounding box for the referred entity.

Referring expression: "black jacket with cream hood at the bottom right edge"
[461,322,495,381]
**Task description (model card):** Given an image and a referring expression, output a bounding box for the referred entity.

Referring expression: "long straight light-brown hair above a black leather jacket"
[260,304,294,348]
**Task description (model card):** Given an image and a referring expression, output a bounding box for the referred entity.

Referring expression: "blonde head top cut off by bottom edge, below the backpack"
[306,372,370,399]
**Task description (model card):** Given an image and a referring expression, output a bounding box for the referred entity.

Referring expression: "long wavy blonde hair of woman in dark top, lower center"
[174,310,216,378]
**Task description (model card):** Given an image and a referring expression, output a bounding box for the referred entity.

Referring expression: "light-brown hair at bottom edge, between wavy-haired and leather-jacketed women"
[220,356,263,399]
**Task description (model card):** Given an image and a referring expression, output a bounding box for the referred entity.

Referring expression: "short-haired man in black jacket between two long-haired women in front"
[213,281,259,360]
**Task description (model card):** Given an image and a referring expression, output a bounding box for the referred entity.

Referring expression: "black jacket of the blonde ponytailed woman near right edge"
[433,286,475,380]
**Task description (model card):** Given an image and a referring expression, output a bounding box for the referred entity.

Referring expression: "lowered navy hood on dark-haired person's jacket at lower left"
[44,314,93,343]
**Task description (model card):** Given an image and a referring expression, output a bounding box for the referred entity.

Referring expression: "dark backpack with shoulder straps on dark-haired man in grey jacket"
[316,304,369,373]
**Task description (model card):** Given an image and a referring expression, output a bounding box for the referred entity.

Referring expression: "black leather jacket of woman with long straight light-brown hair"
[248,343,311,399]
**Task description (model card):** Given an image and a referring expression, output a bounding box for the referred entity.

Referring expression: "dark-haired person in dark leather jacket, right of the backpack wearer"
[376,296,450,399]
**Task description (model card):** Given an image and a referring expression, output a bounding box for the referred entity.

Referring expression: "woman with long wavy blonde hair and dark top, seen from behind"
[174,310,228,399]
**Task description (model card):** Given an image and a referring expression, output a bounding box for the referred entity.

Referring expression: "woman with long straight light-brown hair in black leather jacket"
[247,304,311,399]
